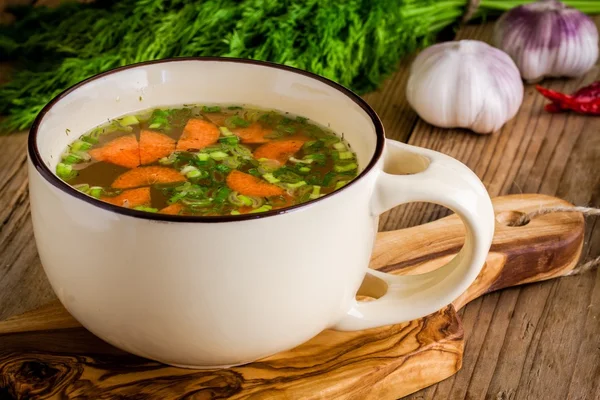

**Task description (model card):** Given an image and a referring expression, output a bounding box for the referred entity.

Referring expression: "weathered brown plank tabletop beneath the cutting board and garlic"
[0,9,600,400]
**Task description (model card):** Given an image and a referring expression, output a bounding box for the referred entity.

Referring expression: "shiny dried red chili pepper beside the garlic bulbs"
[536,81,600,115]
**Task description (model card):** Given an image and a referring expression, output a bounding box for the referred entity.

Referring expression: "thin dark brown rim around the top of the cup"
[27,57,385,223]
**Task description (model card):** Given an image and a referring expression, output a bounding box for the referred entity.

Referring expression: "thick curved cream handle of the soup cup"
[332,139,495,331]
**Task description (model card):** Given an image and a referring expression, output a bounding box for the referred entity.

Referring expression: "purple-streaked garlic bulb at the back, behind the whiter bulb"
[494,0,598,82]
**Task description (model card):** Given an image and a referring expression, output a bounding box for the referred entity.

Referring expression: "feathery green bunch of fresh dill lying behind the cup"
[0,0,600,131]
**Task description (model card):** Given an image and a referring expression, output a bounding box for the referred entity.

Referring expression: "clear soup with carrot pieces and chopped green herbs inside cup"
[56,105,358,216]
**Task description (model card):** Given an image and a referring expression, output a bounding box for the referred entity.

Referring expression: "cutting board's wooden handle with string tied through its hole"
[368,194,585,309]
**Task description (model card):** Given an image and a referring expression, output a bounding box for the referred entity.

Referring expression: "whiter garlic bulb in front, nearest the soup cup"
[406,40,523,133]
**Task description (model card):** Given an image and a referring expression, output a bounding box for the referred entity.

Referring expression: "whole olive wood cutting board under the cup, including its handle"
[0,194,584,399]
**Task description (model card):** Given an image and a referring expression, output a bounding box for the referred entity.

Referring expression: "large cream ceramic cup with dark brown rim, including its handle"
[28,58,494,368]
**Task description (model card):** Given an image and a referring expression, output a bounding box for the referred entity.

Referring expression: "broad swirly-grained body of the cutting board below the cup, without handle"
[0,307,462,399]
